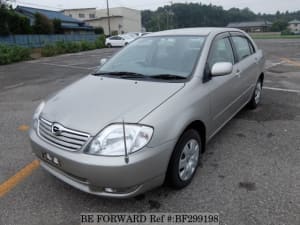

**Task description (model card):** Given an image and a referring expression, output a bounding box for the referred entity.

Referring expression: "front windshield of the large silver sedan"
[97,36,205,78]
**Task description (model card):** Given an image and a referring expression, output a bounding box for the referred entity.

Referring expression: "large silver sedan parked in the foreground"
[30,28,264,198]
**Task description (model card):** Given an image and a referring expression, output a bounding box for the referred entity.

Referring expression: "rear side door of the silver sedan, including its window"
[231,32,259,105]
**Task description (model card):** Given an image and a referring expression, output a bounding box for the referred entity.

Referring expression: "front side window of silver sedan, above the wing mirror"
[207,37,234,70]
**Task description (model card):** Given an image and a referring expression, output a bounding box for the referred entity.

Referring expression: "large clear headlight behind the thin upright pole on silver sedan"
[86,124,153,156]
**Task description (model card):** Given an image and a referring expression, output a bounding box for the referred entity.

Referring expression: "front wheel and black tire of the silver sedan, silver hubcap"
[166,129,202,189]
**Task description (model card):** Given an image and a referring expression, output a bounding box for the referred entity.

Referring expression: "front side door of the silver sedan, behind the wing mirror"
[205,33,241,133]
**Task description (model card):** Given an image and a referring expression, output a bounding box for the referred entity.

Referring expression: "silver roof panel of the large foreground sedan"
[147,27,243,37]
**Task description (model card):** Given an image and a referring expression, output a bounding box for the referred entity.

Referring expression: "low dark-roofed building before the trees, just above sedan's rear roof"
[227,21,272,33]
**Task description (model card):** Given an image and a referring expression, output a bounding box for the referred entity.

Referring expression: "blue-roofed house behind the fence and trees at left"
[15,6,94,34]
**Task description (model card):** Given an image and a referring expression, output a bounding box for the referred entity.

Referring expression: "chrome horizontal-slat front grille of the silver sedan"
[38,118,90,151]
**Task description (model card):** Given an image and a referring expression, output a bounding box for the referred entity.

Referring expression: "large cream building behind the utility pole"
[63,7,142,35]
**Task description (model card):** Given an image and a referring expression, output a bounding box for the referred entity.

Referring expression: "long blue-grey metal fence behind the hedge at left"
[0,34,99,48]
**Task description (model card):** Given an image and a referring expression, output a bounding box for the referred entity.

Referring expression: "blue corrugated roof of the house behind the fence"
[16,6,83,24]
